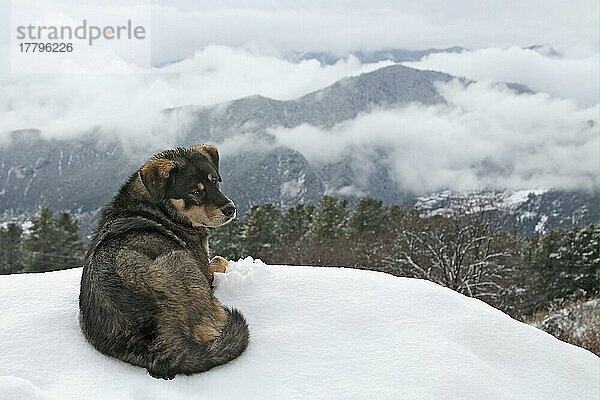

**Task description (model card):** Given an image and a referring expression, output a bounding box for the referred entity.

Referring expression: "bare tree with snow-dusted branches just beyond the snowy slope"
[386,198,512,301]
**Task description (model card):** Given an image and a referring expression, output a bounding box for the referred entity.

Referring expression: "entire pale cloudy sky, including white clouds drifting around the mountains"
[0,0,599,194]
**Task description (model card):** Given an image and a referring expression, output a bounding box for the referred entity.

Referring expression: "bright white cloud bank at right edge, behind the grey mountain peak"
[403,47,599,106]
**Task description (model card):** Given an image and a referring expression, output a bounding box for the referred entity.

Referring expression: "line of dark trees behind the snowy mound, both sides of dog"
[0,196,600,318]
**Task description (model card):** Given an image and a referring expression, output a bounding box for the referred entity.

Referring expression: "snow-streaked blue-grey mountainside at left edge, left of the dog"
[0,130,138,217]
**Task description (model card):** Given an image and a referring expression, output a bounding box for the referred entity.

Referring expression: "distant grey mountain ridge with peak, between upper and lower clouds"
[176,65,453,139]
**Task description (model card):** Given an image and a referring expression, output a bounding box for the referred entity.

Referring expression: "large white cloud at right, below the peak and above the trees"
[271,81,599,194]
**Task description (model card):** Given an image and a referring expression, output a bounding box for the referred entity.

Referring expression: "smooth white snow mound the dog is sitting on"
[0,259,599,400]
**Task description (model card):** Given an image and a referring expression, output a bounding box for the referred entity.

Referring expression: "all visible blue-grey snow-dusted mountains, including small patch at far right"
[0,65,598,236]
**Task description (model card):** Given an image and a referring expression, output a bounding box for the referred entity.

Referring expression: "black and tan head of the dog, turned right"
[139,145,236,228]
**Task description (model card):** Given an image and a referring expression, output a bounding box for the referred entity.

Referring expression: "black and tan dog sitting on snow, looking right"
[79,145,249,379]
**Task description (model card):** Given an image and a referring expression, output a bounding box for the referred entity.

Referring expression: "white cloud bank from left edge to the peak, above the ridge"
[0,46,390,145]
